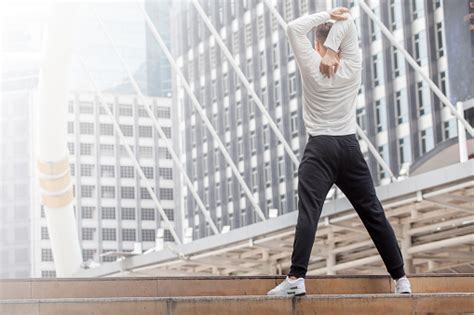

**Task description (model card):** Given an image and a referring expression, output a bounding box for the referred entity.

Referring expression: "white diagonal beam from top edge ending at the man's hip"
[191,0,299,166]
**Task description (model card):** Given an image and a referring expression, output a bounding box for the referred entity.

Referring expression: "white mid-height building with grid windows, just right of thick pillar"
[34,92,181,277]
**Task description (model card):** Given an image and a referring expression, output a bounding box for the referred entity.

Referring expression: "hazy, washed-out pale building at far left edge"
[0,5,45,278]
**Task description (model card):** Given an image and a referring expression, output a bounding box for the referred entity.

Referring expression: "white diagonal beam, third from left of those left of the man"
[136,2,266,221]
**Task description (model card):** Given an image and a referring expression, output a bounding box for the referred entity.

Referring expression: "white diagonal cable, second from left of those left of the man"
[94,11,219,234]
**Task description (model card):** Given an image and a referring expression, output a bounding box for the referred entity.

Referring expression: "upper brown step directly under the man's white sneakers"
[0,274,474,300]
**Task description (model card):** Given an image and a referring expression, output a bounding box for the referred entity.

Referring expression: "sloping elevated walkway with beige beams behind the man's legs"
[75,160,474,277]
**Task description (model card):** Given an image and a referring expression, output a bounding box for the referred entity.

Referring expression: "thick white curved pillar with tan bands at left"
[37,4,82,277]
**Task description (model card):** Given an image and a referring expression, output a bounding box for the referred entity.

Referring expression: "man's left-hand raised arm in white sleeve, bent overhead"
[286,12,330,76]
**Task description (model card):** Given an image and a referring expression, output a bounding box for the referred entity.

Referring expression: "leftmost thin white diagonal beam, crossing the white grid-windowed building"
[79,58,182,244]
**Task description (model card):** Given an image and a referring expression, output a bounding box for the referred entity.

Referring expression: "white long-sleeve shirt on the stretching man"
[287,12,362,136]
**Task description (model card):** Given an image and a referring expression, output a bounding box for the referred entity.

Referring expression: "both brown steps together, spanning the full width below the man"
[0,274,474,315]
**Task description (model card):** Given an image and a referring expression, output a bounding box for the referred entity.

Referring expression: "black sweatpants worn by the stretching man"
[288,134,405,279]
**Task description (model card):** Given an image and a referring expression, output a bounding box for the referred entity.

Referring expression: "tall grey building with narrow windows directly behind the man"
[173,0,474,239]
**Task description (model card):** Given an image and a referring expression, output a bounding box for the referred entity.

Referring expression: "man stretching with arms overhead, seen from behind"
[268,7,411,296]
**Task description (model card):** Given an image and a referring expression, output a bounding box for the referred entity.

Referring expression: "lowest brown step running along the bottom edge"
[0,292,474,315]
